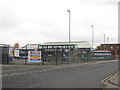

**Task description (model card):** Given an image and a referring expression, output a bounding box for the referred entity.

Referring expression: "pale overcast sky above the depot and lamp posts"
[0,0,118,46]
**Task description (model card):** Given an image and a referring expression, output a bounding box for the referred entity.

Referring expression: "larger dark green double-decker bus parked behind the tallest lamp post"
[38,44,77,63]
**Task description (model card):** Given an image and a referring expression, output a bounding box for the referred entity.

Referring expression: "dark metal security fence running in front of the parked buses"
[13,49,115,65]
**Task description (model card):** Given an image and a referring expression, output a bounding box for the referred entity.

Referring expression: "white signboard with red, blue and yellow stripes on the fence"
[28,51,41,62]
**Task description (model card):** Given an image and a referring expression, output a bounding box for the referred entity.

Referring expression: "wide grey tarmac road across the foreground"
[2,61,118,88]
